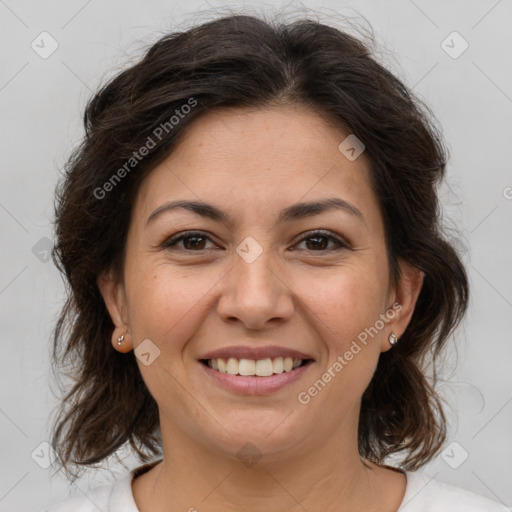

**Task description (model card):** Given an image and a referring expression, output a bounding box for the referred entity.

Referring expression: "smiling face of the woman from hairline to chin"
[100,106,421,457]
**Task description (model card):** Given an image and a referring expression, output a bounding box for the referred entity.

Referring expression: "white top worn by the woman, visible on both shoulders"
[44,468,510,512]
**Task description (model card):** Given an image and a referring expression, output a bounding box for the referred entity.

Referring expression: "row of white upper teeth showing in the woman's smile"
[208,357,302,377]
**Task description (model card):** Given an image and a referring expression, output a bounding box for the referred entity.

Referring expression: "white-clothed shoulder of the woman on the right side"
[398,471,509,512]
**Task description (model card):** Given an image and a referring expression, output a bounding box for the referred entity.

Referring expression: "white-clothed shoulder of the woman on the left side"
[43,472,138,512]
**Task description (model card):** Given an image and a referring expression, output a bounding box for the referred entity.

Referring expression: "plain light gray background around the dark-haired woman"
[0,0,512,512]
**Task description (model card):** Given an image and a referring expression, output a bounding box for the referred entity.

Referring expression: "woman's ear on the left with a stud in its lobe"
[97,271,133,353]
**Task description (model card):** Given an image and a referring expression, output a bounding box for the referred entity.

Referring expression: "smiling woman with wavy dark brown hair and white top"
[46,12,505,512]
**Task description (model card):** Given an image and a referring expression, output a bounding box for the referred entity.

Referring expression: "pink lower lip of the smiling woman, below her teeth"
[199,361,313,395]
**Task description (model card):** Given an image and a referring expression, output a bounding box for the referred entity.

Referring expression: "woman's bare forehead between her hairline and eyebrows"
[132,106,377,226]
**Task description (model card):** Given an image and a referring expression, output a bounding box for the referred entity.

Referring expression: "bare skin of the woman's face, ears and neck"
[98,105,423,512]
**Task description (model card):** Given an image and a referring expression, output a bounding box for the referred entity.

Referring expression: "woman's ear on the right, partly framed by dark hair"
[381,260,425,352]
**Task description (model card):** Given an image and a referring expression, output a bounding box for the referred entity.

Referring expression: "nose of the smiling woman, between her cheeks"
[217,249,294,329]
